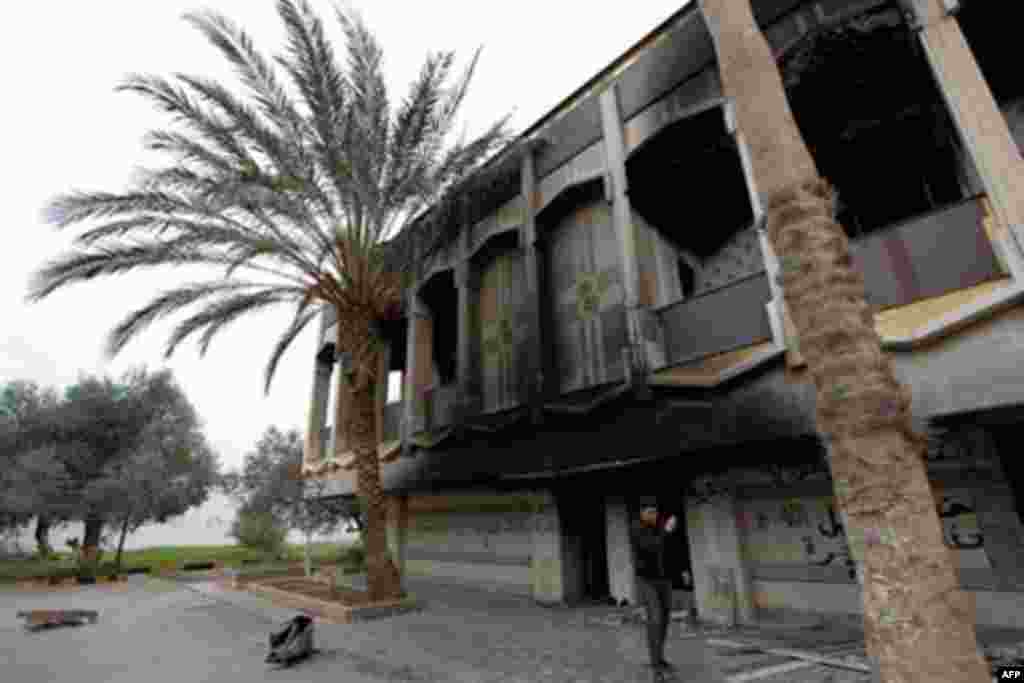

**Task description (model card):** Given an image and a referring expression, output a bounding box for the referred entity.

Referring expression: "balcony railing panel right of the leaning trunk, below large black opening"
[851,192,1002,310]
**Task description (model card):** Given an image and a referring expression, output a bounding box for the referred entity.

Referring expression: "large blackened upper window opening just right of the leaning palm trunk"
[780,8,973,237]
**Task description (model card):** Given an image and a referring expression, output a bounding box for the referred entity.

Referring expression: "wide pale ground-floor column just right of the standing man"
[686,496,756,625]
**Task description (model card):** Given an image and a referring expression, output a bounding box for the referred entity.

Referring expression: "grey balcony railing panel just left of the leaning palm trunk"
[656,271,772,365]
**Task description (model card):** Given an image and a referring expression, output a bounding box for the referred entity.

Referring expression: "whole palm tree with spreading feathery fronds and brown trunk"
[29,0,508,599]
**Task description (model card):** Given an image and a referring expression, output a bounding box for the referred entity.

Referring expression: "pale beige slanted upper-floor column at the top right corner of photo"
[917,0,1024,278]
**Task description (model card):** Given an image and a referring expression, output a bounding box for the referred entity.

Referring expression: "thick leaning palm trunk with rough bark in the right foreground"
[700,0,989,683]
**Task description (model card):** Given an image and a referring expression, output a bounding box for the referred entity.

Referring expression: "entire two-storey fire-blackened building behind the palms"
[305,0,1024,628]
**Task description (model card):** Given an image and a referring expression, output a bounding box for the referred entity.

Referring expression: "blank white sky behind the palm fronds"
[0,0,685,544]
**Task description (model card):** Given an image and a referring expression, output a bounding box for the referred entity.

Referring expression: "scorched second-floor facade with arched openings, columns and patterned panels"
[303,0,1024,464]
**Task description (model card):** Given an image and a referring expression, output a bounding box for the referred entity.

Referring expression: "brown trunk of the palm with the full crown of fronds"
[335,319,401,600]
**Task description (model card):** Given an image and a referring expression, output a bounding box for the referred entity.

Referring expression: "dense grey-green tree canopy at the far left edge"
[0,370,219,557]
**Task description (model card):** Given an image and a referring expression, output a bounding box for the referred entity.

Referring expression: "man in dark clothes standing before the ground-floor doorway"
[631,498,677,673]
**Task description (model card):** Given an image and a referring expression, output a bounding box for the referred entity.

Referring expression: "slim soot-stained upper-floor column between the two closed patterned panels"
[519,147,547,422]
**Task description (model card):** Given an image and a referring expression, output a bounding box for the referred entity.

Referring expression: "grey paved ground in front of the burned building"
[0,578,1022,683]
